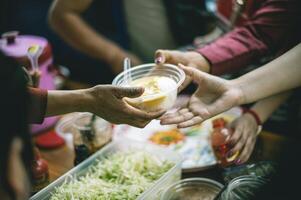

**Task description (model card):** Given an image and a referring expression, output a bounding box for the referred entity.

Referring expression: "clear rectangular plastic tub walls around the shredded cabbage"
[30,140,182,200]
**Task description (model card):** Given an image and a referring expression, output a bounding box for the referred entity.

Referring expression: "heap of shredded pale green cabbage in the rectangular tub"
[51,151,174,200]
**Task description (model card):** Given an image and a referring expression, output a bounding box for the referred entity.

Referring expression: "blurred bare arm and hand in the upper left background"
[49,0,140,73]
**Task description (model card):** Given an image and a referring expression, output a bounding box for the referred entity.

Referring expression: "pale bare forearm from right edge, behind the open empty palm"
[230,44,301,104]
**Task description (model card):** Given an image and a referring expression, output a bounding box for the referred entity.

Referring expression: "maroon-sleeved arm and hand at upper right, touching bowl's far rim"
[155,0,301,75]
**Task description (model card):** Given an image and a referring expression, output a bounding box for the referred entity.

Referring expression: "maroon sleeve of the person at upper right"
[197,0,301,75]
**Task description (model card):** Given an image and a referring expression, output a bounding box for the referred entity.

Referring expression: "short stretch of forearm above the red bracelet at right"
[251,92,291,123]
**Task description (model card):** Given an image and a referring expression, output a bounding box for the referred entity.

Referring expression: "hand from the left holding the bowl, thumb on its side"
[88,85,165,128]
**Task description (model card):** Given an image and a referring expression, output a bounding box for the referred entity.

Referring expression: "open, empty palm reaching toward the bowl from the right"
[160,64,242,128]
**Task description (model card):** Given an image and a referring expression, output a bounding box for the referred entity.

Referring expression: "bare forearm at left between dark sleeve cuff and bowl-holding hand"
[46,89,91,117]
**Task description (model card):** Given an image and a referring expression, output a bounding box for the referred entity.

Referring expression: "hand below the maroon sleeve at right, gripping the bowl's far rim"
[155,50,210,91]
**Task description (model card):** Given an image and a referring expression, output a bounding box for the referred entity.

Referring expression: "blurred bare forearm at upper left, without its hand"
[49,0,121,62]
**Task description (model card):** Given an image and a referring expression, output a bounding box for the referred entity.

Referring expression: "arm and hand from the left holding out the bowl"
[30,85,164,127]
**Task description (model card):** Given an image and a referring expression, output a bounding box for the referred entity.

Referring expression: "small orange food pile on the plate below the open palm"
[149,129,185,145]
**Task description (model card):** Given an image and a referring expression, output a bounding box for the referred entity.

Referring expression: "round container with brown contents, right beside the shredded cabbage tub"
[161,178,223,200]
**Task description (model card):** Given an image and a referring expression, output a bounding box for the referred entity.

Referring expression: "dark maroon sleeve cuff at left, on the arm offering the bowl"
[28,87,48,123]
